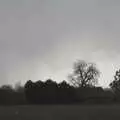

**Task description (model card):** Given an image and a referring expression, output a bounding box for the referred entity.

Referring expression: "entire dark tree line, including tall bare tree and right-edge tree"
[0,60,120,105]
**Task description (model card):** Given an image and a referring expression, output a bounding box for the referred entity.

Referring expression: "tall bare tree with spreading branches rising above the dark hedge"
[68,60,100,87]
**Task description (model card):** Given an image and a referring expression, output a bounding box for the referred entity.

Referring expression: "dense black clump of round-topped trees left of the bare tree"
[25,79,75,104]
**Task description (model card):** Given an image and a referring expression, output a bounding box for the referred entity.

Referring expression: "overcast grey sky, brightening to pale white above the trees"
[0,0,120,87]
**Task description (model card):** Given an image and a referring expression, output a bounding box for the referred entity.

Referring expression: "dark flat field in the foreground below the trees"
[0,105,120,120]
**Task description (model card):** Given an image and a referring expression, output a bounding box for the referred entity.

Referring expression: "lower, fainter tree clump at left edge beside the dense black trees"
[0,85,26,105]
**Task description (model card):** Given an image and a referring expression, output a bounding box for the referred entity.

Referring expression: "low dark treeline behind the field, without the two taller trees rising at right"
[0,79,119,105]
